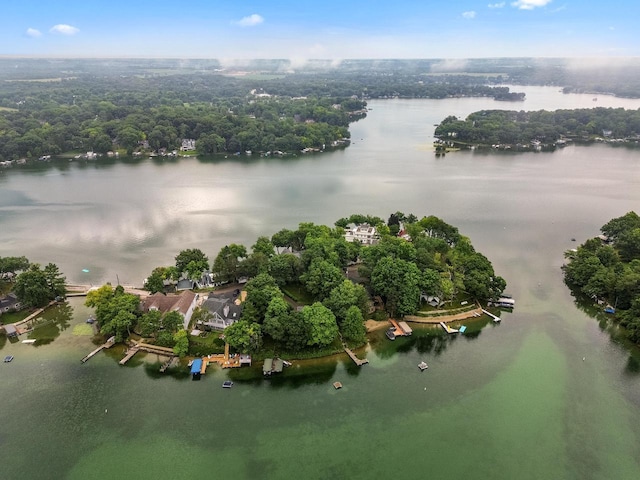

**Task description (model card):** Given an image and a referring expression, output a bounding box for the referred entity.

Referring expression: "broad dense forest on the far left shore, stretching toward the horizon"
[0,61,523,162]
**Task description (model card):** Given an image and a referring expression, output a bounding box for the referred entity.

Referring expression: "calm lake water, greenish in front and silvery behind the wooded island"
[0,87,640,479]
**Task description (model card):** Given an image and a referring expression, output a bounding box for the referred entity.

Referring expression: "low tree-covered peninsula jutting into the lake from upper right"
[435,107,640,146]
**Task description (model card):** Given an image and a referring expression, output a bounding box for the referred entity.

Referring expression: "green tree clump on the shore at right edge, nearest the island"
[563,211,640,344]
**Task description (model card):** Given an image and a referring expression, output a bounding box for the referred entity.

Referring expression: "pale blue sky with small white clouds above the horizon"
[0,0,640,61]
